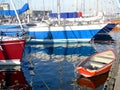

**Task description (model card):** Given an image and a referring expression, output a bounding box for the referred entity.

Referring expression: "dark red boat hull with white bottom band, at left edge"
[0,36,26,65]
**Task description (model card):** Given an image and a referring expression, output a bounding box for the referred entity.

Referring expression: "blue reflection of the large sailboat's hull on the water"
[26,43,95,56]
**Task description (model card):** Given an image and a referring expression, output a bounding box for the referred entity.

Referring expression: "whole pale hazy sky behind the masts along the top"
[0,0,120,13]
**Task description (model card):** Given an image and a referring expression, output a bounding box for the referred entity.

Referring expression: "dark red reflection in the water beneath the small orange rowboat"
[76,72,108,90]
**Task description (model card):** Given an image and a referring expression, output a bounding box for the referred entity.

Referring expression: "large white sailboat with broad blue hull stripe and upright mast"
[0,0,117,43]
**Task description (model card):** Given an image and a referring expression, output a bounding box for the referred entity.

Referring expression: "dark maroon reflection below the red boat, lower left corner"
[0,66,30,90]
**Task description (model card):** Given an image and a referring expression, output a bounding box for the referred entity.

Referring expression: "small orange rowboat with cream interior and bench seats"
[76,49,116,77]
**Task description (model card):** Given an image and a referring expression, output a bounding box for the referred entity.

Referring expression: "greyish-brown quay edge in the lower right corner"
[103,52,120,90]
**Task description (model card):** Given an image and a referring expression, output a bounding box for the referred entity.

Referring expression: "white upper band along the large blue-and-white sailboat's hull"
[28,24,107,32]
